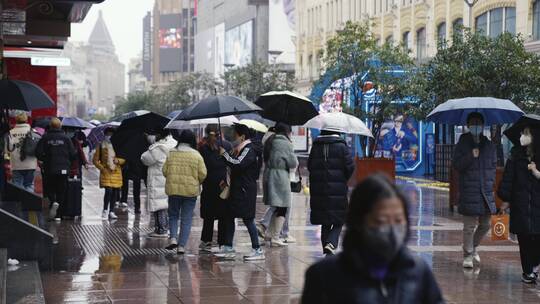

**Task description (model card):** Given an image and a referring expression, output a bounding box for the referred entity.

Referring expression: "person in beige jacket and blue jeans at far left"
[5,113,38,192]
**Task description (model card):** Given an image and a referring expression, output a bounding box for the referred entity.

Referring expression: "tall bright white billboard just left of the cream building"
[268,0,296,64]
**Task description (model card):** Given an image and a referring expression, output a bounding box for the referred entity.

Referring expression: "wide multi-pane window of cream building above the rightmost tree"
[475,7,516,38]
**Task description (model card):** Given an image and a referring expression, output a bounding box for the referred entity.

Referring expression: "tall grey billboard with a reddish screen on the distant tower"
[157,14,182,72]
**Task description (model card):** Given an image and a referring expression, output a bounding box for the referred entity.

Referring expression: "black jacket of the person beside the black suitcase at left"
[36,129,77,175]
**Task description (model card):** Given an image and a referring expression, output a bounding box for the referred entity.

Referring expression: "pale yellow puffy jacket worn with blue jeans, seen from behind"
[163,144,206,197]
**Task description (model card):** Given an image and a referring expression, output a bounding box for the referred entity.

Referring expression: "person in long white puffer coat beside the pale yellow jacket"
[141,130,176,238]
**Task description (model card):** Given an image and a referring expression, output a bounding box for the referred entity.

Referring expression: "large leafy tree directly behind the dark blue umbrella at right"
[415,29,540,115]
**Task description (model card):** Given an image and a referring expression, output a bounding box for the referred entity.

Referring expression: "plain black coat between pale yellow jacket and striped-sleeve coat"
[199,141,232,220]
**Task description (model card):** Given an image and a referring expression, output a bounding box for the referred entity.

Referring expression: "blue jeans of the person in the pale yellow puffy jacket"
[168,195,197,247]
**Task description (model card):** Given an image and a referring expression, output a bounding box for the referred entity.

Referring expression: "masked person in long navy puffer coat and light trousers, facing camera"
[452,113,497,268]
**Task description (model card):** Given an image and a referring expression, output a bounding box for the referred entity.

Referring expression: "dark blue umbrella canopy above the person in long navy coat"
[427,97,524,125]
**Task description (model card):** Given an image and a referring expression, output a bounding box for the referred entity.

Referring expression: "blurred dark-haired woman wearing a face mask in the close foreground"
[301,175,444,304]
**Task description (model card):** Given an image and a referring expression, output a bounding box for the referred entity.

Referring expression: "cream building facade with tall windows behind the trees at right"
[295,0,540,94]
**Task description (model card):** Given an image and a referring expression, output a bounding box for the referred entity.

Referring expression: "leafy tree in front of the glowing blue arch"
[314,21,417,155]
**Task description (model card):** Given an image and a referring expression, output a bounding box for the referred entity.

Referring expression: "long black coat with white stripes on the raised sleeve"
[223,143,262,219]
